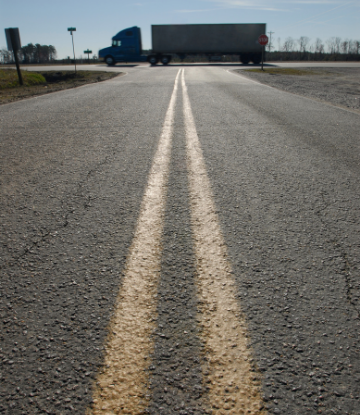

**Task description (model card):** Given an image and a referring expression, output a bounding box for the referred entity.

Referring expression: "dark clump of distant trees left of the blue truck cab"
[0,43,57,63]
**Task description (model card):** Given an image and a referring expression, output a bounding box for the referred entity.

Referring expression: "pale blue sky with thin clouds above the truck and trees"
[0,0,360,59]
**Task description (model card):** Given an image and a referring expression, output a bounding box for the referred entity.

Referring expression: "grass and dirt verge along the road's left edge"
[0,69,122,104]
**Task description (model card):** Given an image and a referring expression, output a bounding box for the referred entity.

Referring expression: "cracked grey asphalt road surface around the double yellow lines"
[0,65,360,415]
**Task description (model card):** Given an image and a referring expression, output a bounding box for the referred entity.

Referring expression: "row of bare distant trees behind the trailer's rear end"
[266,36,360,60]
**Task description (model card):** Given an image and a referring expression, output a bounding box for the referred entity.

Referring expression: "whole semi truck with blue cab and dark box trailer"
[99,23,266,65]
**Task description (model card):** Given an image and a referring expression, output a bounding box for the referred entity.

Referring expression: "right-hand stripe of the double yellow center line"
[181,72,265,415]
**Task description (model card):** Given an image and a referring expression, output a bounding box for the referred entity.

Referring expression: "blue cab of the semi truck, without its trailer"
[99,26,148,66]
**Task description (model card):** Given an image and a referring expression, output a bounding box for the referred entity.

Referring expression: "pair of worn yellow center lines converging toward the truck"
[88,69,264,415]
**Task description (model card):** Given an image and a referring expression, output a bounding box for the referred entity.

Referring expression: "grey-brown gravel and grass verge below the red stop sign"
[235,68,360,112]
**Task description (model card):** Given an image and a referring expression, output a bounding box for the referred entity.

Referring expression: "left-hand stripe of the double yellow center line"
[88,71,180,415]
